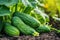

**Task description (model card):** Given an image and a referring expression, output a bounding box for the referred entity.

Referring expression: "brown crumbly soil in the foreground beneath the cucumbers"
[0,31,60,40]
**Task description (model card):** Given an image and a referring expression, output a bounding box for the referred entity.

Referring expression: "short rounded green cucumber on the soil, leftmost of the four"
[4,23,20,36]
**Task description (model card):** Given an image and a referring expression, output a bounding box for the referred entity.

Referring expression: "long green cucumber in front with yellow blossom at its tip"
[12,16,39,36]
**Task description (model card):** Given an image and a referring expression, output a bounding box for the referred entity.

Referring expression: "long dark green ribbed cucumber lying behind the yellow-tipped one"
[14,12,40,28]
